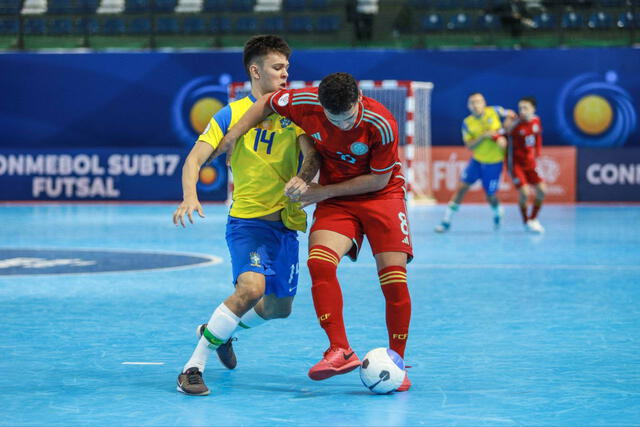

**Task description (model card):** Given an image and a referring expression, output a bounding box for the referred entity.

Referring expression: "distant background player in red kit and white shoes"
[505,97,545,233]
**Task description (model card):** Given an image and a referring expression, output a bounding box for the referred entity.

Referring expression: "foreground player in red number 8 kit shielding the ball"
[221,73,413,391]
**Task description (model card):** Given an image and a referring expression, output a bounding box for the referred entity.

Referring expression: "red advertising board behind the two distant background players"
[430,146,576,203]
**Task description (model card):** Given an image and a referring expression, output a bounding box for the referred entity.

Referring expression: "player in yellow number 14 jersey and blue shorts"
[173,35,320,395]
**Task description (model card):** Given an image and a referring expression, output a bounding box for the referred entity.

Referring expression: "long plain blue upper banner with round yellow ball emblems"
[0,46,640,150]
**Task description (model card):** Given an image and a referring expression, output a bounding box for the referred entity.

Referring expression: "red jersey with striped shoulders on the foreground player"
[269,87,405,200]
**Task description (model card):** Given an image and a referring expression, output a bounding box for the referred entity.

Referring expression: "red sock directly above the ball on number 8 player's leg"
[378,266,411,358]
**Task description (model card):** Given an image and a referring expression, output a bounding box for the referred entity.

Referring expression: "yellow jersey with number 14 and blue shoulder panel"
[198,95,307,232]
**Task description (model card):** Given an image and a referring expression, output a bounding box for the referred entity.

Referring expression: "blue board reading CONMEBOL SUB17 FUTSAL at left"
[0,148,227,201]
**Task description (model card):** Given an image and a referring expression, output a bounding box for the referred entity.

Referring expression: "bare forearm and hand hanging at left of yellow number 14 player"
[173,140,214,227]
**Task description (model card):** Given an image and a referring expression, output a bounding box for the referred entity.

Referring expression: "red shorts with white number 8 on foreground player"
[311,199,413,261]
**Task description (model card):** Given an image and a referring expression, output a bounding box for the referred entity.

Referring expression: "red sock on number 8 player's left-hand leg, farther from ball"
[307,245,349,348]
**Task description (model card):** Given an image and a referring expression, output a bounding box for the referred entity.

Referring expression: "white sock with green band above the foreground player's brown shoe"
[182,303,240,372]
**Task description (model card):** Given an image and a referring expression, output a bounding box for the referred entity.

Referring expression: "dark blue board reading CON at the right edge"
[578,148,640,202]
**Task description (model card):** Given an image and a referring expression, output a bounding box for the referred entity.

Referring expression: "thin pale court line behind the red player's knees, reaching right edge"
[340,263,640,271]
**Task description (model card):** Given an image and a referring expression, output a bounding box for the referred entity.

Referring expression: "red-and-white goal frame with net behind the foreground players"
[228,80,433,204]
